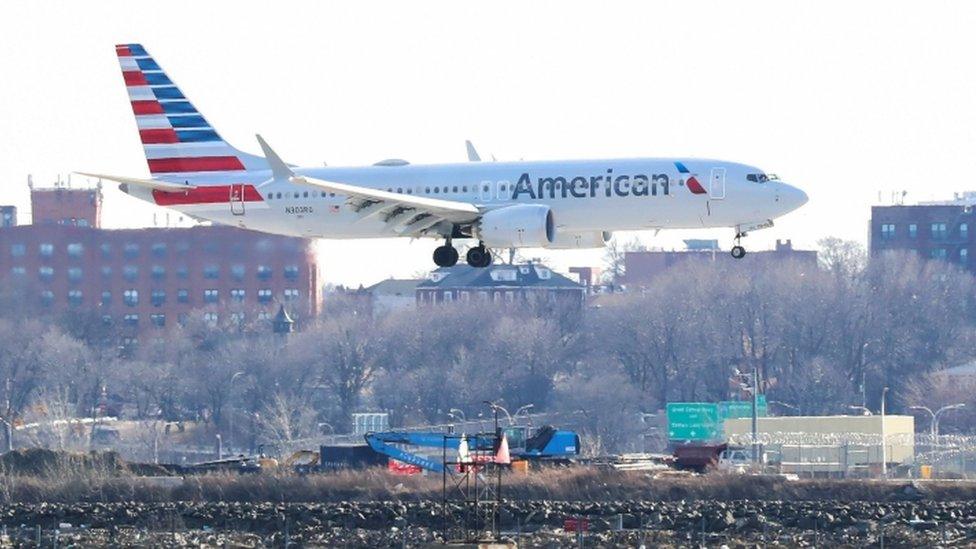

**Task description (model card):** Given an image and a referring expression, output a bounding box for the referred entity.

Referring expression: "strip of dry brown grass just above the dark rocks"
[0,460,976,503]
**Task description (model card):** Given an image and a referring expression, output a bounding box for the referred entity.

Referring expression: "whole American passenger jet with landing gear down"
[84,44,807,267]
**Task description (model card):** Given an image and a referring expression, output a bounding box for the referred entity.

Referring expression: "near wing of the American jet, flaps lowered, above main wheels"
[289,175,481,236]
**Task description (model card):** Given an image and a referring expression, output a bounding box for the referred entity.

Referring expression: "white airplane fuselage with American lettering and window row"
[143,158,806,239]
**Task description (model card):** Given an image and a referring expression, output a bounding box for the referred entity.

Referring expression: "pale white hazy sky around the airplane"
[0,0,976,284]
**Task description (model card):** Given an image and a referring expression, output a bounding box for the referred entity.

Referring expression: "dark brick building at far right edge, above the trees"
[869,192,976,273]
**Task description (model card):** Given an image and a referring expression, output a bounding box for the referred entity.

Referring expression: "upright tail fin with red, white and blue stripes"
[115,44,268,181]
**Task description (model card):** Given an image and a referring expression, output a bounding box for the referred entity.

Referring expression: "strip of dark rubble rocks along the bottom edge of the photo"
[0,500,976,547]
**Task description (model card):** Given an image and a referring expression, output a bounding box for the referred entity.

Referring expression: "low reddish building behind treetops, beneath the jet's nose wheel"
[624,240,817,286]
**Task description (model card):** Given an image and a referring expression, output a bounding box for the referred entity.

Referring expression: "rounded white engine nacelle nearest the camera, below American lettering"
[474,204,556,248]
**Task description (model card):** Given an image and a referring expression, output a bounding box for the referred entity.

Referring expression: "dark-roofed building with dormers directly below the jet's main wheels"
[416,263,586,307]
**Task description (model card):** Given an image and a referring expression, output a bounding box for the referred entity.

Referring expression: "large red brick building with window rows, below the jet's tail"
[0,184,321,337]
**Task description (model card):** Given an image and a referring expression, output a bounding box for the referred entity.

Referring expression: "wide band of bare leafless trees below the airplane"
[0,241,976,449]
